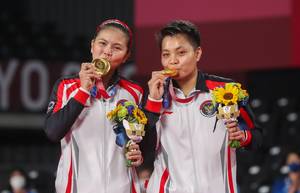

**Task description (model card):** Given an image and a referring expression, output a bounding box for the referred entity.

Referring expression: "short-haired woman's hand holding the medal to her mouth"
[148,71,166,100]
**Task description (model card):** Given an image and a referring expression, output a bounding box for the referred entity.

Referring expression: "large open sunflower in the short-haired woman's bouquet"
[212,83,239,106]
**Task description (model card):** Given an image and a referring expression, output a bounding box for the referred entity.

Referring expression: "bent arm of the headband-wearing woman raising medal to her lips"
[44,63,97,141]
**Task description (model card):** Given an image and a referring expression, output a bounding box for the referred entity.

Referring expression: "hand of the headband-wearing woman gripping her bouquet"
[126,143,143,167]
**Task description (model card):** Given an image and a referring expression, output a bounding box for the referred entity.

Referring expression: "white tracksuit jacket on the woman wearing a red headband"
[45,75,143,193]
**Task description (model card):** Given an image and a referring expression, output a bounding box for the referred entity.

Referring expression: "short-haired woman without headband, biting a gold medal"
[145,20,262,193]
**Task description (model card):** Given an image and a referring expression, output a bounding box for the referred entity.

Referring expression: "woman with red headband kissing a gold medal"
[45,19,143,193]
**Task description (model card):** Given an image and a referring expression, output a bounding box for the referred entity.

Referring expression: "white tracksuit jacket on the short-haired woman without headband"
[145,72,261,193]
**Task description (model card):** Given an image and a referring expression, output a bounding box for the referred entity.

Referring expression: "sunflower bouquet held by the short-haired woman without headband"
[212,83,249,148]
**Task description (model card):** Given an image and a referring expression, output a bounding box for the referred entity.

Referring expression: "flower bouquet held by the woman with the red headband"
[107,100,147,166]
